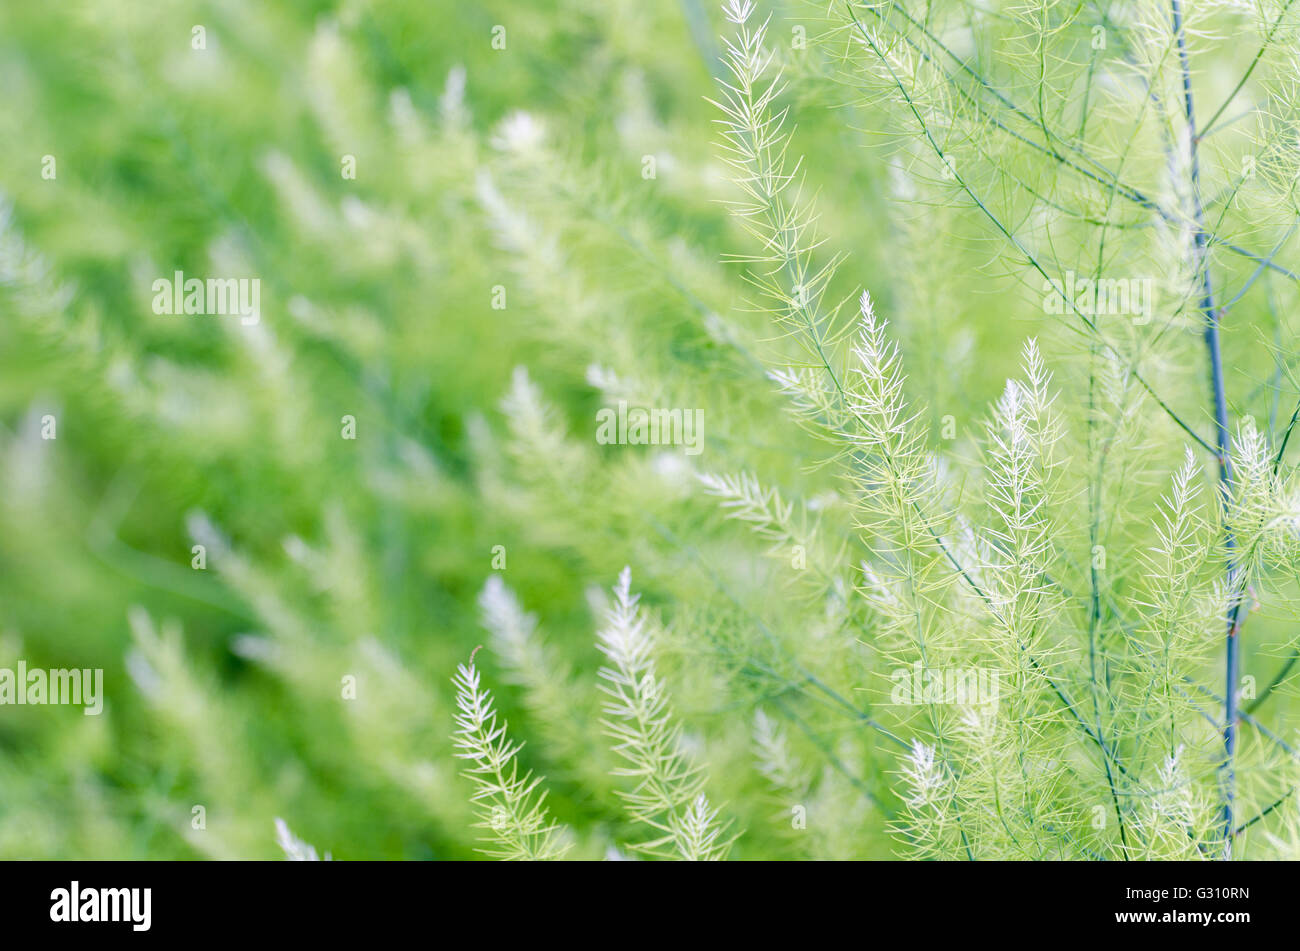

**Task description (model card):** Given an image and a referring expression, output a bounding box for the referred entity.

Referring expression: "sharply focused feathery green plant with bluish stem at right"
[454,0,1300,859]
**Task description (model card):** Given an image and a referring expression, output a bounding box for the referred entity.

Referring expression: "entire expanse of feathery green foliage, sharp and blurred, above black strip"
[0,0,1300,860]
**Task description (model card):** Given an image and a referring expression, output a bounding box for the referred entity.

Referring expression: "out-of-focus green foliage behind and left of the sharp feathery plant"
[0,0,1300,859]
